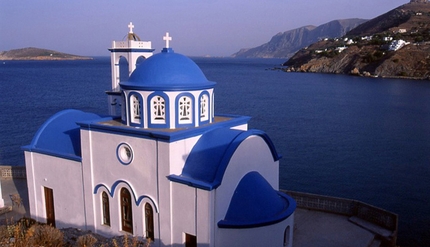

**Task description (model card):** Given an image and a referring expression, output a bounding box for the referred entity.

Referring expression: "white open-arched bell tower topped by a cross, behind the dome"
[106,22,155,116]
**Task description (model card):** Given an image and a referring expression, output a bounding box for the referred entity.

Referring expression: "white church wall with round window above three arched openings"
[81,130,159,239]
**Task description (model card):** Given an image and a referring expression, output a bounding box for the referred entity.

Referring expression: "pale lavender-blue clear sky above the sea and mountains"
[0,0,409,56]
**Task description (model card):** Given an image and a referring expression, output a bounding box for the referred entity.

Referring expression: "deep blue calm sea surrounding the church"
[0,57,430,246]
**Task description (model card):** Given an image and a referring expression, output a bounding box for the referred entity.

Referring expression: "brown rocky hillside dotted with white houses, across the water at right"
[284,2,430,79]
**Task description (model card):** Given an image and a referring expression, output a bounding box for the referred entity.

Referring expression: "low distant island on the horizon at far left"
[0,47,92,60]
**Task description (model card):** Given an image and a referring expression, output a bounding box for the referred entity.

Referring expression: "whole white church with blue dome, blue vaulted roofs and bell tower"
[23,23,296,247]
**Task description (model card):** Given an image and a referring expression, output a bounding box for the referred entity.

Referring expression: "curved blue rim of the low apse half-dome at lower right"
[218,191,297,229]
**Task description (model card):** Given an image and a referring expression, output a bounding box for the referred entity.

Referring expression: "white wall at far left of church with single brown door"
[25,151,86,229]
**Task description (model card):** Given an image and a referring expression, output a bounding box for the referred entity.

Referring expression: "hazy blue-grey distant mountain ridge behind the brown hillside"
[232,19,366,58]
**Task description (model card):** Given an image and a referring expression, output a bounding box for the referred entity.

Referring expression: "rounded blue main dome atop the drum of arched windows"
[120,48,215,91]
